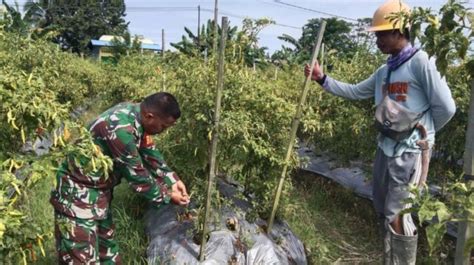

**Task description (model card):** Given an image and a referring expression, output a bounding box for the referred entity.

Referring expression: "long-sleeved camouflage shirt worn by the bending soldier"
[51,103,179,219]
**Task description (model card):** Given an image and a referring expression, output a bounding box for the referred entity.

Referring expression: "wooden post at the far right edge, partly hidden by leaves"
[454,79,474,265]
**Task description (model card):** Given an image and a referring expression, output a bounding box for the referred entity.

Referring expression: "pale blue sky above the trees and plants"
[125,0,474,53]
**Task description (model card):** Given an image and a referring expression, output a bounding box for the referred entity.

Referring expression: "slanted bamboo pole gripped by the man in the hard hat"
[267,20,326,233]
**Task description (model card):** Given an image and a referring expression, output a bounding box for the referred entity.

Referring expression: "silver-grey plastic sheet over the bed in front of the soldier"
[145,180,307,265]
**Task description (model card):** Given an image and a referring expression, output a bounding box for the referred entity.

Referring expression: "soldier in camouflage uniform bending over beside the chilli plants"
[50,92,189,264]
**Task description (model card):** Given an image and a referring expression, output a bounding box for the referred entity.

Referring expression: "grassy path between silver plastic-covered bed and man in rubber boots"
[287,169,382,264]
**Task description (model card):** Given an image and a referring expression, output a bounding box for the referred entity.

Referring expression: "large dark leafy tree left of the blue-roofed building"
[36,0,128,54]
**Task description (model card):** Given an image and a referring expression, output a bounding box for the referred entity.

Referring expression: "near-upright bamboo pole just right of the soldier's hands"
[199,17,227,261]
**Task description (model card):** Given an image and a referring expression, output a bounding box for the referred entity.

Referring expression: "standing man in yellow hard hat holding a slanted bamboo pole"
[305,0,456,264]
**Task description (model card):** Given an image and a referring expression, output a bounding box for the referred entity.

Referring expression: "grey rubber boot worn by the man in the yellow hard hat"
[384,227,418,265]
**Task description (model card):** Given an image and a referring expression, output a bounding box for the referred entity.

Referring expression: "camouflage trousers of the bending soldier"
[54,211,122,264]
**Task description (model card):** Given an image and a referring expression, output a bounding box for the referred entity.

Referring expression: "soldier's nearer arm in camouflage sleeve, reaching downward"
[108,128,170,205]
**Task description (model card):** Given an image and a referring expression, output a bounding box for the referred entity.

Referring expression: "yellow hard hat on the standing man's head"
[367,0,410,31]
